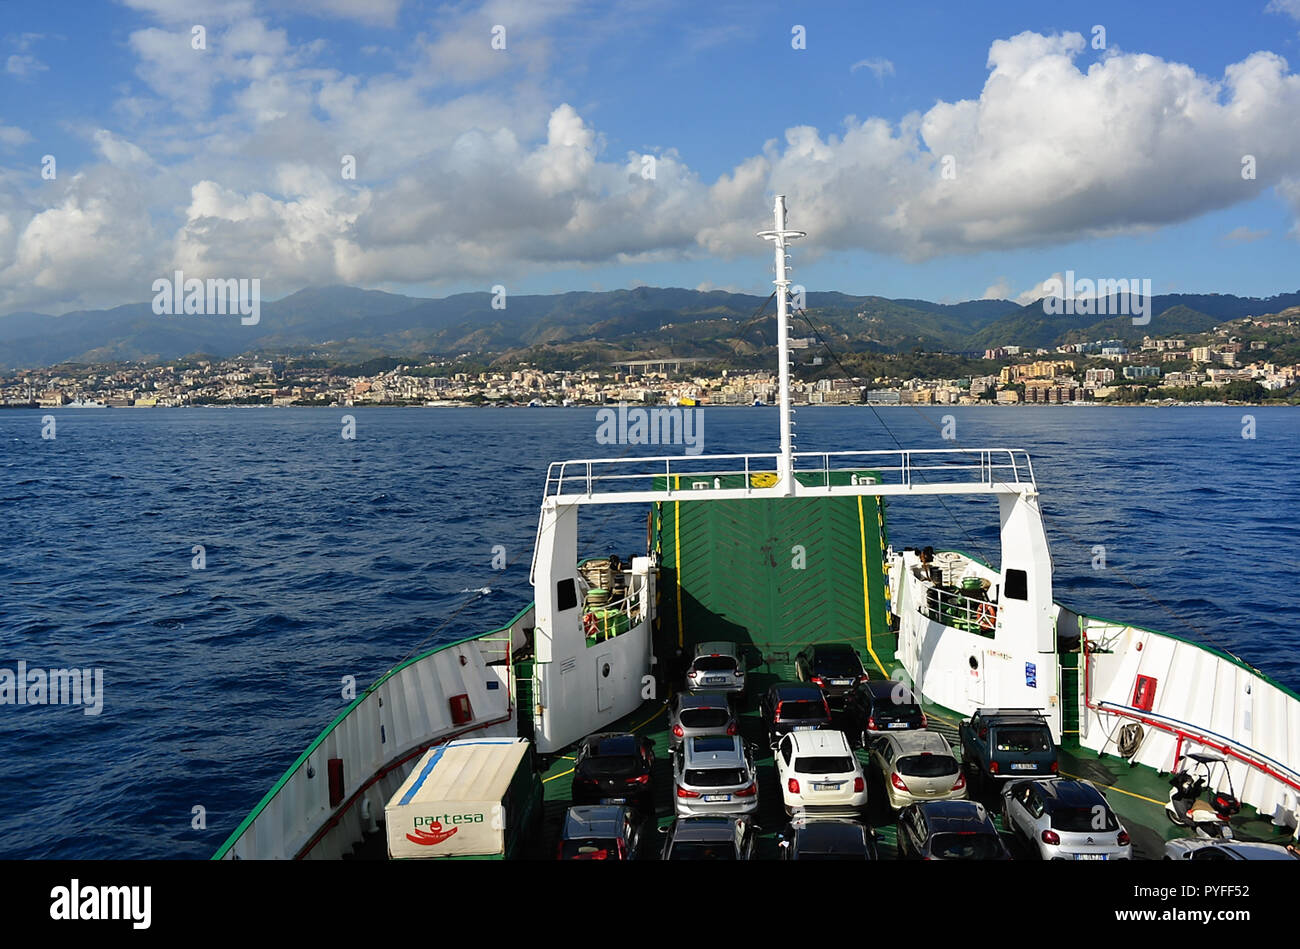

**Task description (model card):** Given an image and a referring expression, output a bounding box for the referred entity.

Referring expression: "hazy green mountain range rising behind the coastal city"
[0,286,1300,369]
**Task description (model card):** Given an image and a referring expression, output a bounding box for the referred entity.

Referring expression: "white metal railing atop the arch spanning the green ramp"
[545,449,1035,499]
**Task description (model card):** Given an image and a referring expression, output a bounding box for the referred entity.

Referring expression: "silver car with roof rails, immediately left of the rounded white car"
[672,735,758,816]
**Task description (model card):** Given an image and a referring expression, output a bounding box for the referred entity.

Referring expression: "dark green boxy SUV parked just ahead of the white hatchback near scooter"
[958,709,1060,784]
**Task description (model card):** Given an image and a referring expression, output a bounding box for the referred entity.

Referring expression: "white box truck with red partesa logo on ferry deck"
[384,738,542,859]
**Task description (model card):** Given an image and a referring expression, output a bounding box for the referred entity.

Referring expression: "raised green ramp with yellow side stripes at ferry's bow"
[655,472,893,676]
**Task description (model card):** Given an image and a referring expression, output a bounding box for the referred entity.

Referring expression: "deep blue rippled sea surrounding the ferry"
[0,407,1300,858]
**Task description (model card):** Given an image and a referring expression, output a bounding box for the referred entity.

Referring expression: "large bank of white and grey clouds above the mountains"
[0,25,1300,312]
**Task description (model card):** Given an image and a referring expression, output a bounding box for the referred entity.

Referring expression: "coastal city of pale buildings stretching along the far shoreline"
[0,311,1300,408]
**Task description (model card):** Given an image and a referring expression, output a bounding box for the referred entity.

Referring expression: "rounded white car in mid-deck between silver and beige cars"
[776,729,867,816]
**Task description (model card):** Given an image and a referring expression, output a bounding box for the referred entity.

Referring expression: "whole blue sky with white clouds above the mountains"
[0,0,1300,312]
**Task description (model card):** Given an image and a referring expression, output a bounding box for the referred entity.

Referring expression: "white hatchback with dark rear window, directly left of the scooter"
[1002,777,1134,861]
